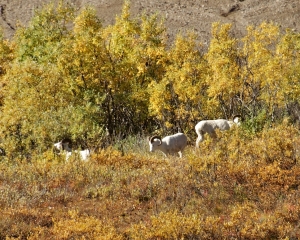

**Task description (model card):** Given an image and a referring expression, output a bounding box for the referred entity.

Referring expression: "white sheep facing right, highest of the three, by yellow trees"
[195,115,242,147]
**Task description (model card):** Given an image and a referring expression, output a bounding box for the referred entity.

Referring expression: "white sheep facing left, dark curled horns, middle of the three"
[148,133,187,158]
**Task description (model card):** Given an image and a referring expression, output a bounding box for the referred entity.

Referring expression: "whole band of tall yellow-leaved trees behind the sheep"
[0,1,300,155]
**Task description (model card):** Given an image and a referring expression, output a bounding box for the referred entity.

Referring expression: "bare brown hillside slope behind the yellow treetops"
[0,0,300,43]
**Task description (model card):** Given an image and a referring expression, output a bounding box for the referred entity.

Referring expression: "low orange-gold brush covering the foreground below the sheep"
[0,126,300,239]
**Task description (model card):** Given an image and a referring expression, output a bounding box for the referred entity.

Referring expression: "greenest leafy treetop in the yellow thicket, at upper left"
[14,1,74,64]
